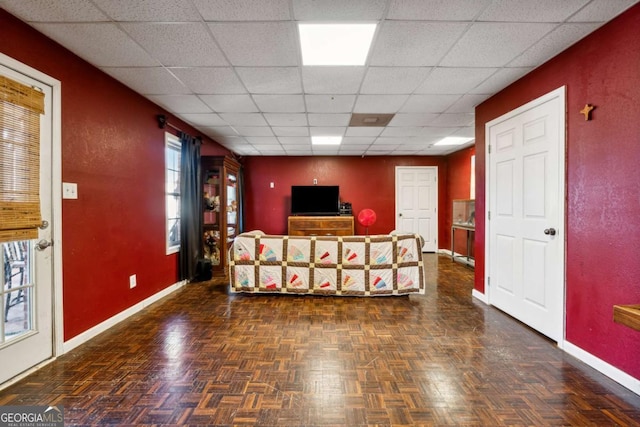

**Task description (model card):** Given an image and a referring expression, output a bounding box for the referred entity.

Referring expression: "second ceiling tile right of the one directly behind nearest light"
[415,67,498,94]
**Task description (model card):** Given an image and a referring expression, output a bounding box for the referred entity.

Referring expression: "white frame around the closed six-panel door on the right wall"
[484,86,567,348]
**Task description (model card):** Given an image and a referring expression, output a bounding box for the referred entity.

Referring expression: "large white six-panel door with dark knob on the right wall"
[486,88,565,342]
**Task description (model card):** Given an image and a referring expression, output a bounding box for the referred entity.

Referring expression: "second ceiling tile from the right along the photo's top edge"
[478,0,589,22]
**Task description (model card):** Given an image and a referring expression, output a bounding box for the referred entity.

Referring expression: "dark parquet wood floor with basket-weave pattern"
[0,254,640,426]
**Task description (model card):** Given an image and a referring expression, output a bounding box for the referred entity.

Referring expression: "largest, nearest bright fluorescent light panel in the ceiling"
[298,23,376,65]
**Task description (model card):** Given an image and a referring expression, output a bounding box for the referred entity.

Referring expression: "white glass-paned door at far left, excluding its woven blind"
[0,65,54,384]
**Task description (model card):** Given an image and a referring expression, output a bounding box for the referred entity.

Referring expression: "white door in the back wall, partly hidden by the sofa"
[396,166,438,252]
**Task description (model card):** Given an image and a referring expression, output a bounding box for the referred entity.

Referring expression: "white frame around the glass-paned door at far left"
[0,53,64,368]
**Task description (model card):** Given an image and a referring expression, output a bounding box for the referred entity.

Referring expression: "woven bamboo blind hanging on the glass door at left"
[0,76,44,242]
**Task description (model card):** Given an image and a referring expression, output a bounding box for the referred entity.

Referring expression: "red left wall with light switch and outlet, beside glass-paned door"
[0,9,226,341]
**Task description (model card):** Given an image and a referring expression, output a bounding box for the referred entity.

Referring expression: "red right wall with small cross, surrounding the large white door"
[476,5,640,378]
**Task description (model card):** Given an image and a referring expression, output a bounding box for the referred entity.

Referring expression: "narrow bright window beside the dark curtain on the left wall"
[164,133,181,255]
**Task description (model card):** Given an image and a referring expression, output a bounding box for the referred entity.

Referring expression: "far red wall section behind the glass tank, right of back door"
[440,147,476,256]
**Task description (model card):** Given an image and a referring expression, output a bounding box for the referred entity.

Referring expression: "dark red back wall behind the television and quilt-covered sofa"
[243,156,448,242]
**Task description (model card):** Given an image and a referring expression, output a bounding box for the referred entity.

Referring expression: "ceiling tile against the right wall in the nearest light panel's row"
[509,23,600,67]
